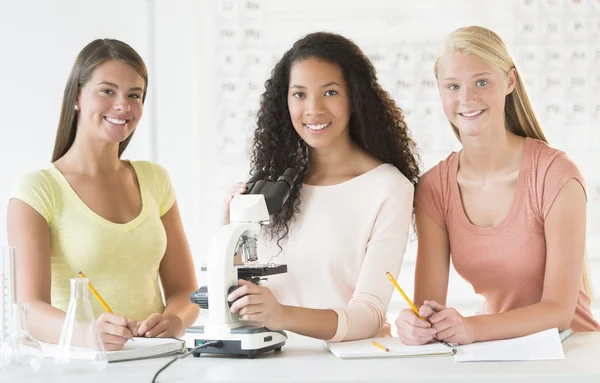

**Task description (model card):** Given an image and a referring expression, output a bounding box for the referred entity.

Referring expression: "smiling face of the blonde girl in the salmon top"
[437,52,516,138]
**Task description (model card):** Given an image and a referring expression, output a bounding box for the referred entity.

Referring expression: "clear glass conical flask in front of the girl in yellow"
[54,278,108,372]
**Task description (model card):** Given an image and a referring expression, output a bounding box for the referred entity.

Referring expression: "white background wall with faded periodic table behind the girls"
[0,0,600,318]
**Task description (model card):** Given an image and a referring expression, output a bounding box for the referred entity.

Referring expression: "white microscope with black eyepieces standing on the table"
[185,168,298,358]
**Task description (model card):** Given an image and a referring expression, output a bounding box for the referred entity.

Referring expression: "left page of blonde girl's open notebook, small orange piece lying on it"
[327,338,456,359]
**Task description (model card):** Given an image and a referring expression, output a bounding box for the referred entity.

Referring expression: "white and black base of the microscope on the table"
[184,326,287,359]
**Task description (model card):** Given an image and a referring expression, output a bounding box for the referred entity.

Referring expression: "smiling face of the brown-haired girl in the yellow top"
[77,60,145,144]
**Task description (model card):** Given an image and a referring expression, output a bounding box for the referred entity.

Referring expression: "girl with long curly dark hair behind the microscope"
[224,33,419,342]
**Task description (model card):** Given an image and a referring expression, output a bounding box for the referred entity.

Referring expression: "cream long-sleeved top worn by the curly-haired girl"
[259,164,414,342]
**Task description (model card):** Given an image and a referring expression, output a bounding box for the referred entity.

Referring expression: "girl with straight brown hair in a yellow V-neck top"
[7,39,198,350]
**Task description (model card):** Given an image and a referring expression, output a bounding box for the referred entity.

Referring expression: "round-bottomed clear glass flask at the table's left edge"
[0,303,44,376]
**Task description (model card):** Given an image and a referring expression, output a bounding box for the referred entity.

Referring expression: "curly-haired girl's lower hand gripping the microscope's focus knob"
[227,279,286,331]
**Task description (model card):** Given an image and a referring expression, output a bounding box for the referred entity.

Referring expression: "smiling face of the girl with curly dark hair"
[288,58,350,149]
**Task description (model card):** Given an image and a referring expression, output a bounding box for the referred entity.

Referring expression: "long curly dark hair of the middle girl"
[250,32,419,247]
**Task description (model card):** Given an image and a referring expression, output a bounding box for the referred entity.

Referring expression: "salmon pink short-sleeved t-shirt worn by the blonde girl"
[415,138,600,331]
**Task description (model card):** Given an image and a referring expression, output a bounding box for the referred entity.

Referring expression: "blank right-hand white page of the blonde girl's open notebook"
[454,328,565,362]
